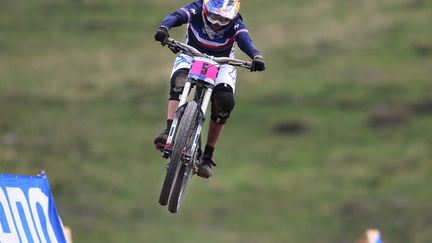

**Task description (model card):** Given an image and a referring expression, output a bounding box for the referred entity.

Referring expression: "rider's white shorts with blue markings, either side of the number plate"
[171,54,237,91]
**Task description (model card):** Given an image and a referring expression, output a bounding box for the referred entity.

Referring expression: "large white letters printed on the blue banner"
[0,187,58,243]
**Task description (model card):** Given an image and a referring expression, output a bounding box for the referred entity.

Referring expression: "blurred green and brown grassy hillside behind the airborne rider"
[0,0,432,243]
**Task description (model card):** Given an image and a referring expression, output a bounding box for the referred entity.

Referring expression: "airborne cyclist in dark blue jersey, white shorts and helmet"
[154,0,265,178]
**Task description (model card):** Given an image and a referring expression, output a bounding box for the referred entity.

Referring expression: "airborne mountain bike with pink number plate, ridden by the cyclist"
[159,38,252,213]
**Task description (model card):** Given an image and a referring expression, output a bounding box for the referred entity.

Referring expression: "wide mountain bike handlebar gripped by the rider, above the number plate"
[166,38,252,70]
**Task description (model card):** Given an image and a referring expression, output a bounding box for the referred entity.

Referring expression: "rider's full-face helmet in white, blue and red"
[203,0,240,31]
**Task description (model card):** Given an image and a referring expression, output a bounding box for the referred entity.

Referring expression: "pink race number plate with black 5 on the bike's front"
[189,57,219,84]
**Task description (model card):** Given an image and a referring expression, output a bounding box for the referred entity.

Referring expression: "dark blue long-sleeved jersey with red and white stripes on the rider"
[161,0,260,58]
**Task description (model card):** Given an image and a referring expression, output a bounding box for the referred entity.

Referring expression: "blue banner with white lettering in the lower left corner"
[0,173,66,243]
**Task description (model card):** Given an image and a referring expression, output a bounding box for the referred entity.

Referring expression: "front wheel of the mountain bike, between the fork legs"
[159,101,198,208]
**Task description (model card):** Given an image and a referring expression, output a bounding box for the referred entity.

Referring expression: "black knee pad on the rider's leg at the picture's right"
[210,84,235,124]
